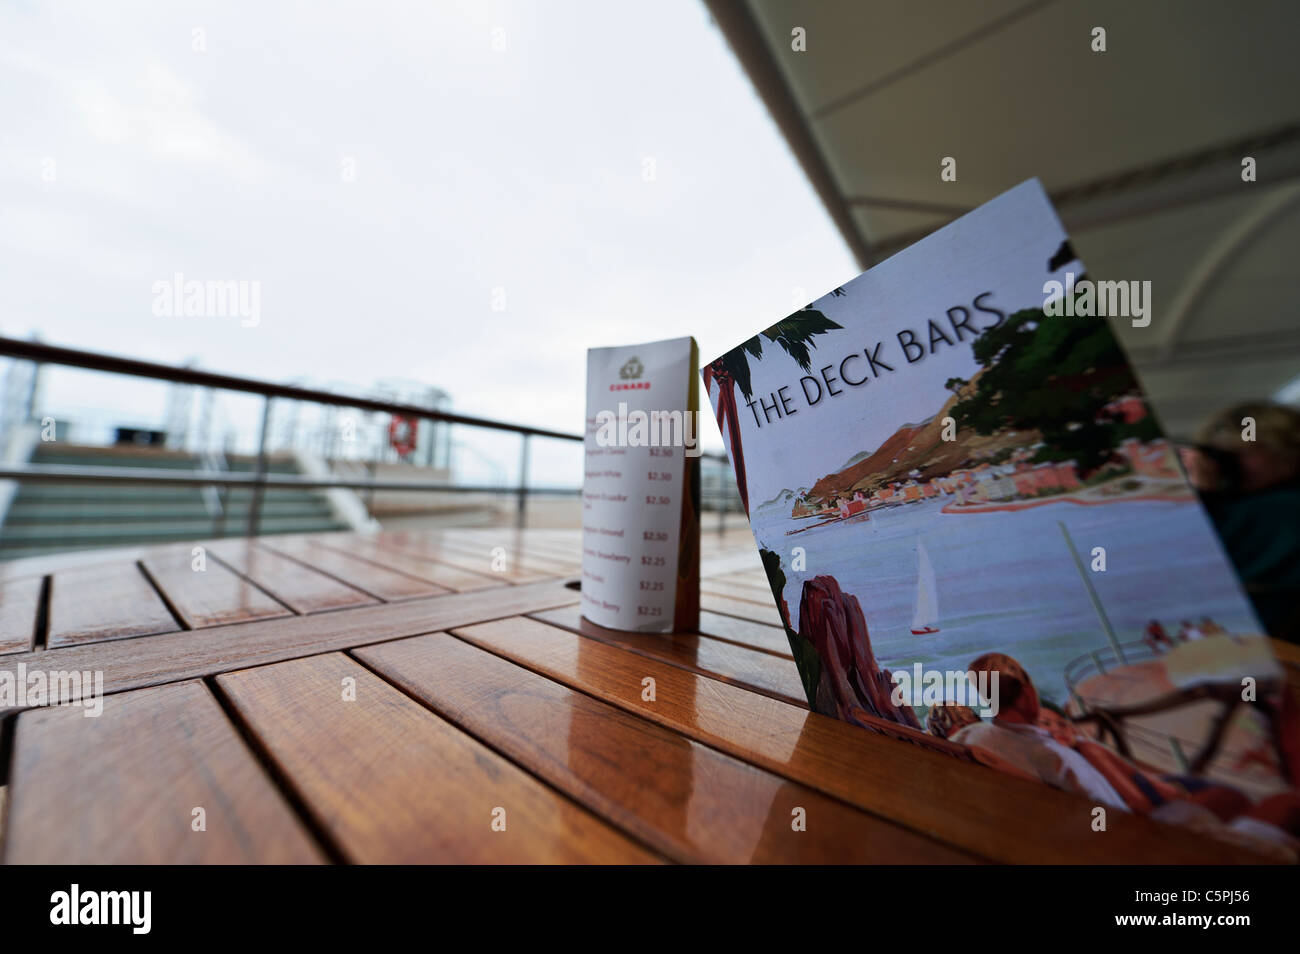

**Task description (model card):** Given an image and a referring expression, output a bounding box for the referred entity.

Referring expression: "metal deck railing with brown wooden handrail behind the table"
[0,337,731,537]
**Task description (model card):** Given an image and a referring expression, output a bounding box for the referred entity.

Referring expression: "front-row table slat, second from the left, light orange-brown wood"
[217,654,655,863]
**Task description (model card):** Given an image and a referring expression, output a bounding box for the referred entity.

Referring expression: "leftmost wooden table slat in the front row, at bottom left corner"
[4,682,325,864]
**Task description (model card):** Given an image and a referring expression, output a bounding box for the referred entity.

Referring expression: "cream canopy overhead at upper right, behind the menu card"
[707,0,1300,437]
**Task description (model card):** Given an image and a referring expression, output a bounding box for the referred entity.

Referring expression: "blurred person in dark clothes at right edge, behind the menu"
[1180,402,1300,642]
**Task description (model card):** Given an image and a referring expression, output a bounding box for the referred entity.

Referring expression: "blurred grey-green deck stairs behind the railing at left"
[0,443,347,560]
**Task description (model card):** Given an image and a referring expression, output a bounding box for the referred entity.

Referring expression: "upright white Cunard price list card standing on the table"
[582,338,699,633]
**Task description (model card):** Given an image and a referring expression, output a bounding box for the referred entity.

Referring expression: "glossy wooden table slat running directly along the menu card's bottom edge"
[444,617,1261,864]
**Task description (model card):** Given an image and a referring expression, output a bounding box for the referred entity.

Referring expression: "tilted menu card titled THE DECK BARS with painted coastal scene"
[703,179,1300,860]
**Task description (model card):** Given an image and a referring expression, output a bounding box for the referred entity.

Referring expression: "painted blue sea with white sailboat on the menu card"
[751,496,1262,706]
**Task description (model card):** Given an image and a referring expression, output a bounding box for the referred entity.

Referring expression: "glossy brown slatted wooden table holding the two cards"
[0,530,1284,863]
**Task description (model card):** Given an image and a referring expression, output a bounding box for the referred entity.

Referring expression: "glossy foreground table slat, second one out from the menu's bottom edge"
[355,634,971,863]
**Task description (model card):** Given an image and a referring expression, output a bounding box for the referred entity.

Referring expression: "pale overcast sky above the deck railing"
[0,0,857,482]
